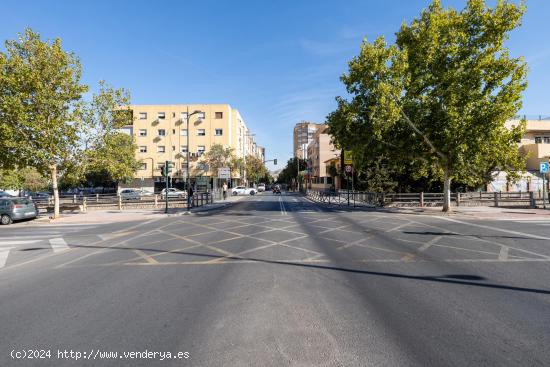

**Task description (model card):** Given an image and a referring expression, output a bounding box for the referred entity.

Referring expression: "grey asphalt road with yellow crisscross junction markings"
[0,193,550,366]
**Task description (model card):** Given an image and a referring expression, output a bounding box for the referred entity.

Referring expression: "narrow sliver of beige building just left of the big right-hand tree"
[307,125,340,189]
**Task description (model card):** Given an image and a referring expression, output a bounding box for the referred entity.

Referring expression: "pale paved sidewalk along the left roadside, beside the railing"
[33,196,246,224]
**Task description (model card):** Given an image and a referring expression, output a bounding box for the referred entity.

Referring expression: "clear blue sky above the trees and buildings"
[0,0,550,168]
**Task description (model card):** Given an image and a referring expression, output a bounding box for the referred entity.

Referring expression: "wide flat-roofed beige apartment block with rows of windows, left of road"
[123,104,265,189]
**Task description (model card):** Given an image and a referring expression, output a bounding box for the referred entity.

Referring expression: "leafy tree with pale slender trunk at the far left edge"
[0,29,87,217]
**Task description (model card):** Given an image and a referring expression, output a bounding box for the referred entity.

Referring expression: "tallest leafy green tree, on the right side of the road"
[328,0,526,211]
